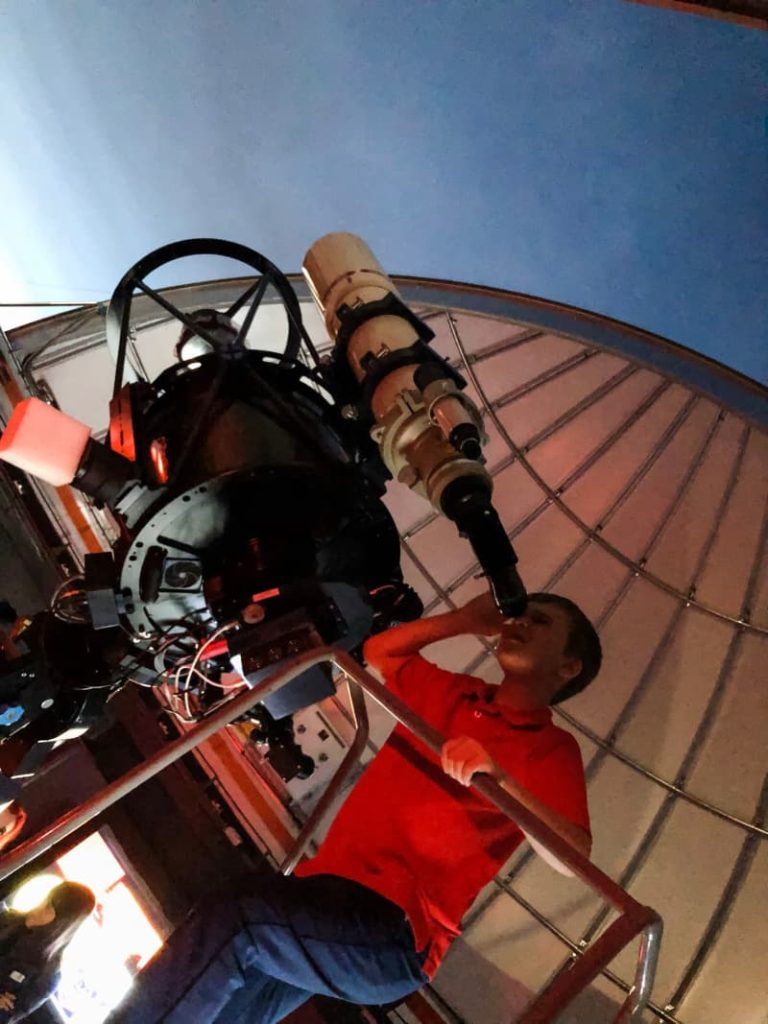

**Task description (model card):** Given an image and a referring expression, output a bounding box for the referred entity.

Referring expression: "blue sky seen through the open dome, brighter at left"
[0,0,768,380]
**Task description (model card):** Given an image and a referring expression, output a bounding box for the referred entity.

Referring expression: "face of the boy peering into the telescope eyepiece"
[496,601,582,695]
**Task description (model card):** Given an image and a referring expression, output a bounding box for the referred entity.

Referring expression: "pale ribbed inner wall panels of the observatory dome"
[1,278,768,1024]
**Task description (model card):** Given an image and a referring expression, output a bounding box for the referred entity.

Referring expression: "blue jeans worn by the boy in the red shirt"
[110,874,427,1024]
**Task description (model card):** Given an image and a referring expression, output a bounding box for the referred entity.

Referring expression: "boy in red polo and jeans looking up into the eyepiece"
[113,594,601,1024]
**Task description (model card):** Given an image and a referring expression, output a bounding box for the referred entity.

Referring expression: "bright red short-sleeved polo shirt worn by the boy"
[296,655,589,977]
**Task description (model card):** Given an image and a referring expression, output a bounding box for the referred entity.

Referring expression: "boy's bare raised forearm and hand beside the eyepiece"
[362,594,503,679]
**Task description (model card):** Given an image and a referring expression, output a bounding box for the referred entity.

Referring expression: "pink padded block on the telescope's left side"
[0,398,91,487]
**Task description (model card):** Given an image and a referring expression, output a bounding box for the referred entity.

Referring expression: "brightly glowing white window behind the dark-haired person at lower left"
[52,833,163,1024]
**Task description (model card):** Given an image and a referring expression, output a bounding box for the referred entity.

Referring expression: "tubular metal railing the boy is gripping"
[0,647,663,1024]
